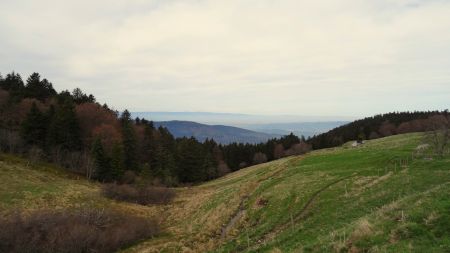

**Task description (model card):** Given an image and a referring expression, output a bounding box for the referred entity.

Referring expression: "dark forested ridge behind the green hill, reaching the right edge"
[307,110,449,149]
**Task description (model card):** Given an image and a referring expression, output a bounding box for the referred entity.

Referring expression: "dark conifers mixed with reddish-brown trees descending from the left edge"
[0,72,311,185]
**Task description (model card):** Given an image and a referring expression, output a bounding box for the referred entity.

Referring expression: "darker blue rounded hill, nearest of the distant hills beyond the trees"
[154,120,281,144]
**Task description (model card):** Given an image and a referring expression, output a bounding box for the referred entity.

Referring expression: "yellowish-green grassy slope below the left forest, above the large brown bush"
[0,154,163,217]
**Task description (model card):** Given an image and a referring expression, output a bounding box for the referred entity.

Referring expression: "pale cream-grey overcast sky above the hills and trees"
[0,0,450,116]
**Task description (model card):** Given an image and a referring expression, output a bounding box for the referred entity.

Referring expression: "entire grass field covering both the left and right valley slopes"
[0,134,450,252]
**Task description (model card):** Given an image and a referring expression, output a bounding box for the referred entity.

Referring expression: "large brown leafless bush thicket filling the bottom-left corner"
[0,209,159,253]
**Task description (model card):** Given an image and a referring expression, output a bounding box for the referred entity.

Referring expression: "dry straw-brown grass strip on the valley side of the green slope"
[128,157,299,252]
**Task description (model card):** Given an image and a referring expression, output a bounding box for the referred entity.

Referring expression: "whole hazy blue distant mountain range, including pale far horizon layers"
[132,112,350,144]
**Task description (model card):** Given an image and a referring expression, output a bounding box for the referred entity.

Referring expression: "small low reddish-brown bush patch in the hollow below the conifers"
[103,184,175,205]
